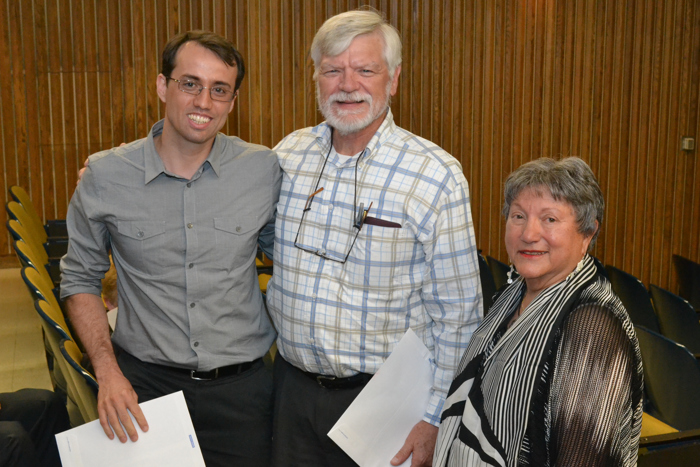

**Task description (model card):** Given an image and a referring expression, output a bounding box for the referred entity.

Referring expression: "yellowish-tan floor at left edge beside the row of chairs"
[0,266,52,392]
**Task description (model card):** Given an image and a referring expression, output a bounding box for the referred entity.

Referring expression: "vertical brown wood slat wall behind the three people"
[0,0,700,290]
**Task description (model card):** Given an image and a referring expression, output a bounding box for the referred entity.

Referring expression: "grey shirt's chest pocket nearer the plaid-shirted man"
[214,213,260,271]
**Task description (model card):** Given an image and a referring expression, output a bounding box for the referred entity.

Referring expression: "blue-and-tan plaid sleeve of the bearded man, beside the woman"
[422,172,483,425]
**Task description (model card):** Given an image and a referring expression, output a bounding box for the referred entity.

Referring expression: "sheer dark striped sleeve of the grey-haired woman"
[549,304,634,466]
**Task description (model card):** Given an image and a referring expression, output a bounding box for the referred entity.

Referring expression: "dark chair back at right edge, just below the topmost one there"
[649,284,700,356]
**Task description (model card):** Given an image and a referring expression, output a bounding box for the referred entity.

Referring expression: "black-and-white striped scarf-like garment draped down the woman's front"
[433,256,641,466]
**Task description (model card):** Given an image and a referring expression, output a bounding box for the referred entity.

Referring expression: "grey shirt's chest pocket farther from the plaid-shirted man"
[117,221,167,274]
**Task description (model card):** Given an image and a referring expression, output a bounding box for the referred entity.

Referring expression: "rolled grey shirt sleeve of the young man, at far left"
[61,160,110,300]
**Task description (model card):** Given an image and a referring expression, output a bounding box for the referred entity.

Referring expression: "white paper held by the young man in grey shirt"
[56,391,204,467]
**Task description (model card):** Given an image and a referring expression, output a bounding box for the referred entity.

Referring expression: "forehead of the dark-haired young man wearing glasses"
[172,41,238,87]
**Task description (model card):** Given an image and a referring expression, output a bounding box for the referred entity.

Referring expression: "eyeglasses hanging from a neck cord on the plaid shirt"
[294,134,372,264]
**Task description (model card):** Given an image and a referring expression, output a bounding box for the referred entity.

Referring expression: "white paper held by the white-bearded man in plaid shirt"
[328,329,433,467]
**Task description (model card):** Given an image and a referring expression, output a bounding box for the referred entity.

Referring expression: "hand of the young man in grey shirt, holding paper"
[97,370,148,443]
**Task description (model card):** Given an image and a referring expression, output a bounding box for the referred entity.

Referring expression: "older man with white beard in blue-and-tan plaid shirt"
[267,11,482,467]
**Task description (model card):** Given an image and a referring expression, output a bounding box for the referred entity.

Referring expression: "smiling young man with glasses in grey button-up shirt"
[61,31,281,466]
